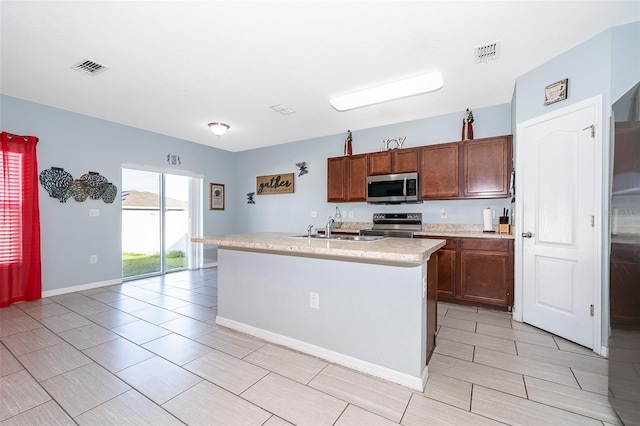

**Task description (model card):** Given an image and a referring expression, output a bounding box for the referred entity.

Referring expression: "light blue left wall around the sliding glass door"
[0,96,234,291]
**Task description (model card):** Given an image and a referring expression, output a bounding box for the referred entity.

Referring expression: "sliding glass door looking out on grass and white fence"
[122,168,201,279]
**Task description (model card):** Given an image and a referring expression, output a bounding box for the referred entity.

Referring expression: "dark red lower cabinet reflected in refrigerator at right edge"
[609,243,640,329]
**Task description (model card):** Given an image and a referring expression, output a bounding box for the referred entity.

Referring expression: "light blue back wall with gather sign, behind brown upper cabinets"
[233,104,511,233]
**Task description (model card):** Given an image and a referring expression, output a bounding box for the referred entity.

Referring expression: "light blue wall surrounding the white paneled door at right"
[513,22,640,346]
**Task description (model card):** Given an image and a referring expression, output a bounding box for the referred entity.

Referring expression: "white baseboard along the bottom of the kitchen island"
[216,315,429,392]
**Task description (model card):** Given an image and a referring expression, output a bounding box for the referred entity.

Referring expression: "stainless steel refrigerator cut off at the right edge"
[609,83,640,426]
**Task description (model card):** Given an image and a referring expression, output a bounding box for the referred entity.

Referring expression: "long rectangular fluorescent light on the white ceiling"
[329,71,444,111]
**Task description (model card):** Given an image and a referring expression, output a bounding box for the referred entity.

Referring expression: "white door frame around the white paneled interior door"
[513,95,607,356]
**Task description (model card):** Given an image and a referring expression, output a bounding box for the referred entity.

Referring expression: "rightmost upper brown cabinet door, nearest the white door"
[462,136,512,198]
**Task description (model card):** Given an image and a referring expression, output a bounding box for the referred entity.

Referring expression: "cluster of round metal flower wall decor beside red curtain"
[39,167,118,204]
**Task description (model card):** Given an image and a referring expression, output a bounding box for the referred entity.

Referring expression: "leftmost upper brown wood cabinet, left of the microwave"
[327,154,367,202]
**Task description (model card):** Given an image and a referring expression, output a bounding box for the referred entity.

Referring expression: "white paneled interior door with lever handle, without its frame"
[517,97,600,348]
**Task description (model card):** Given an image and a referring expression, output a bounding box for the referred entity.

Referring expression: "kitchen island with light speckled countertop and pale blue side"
[192,233,445,390]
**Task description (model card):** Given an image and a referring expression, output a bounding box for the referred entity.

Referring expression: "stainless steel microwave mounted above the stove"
[367,173,421,204]
